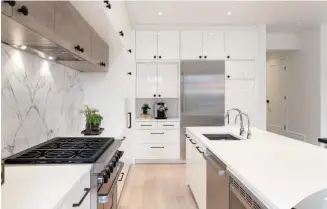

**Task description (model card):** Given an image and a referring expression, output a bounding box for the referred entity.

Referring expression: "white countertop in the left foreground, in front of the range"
[1,164,92,209]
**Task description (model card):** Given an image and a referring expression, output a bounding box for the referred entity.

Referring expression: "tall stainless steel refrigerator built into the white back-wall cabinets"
[180,60,225,160]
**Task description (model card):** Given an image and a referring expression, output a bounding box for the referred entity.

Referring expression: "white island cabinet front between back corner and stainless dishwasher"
[186,134,207,209]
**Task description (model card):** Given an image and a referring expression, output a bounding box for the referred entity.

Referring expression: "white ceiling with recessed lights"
[126,1,327,30]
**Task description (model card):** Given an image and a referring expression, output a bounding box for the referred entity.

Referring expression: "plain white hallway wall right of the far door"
[287,27,321,144]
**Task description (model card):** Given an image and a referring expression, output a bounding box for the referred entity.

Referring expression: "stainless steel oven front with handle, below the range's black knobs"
[97,162,124,209]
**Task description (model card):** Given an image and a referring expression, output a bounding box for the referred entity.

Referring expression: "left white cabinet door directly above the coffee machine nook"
[135,63,157,98]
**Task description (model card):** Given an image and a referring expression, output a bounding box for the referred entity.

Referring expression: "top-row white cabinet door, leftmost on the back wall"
[135,31,158,60]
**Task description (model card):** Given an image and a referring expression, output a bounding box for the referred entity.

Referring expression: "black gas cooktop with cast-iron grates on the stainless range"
[4,137,114,164]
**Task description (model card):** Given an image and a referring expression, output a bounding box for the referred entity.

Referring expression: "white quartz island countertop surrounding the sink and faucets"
[187,126,327,209]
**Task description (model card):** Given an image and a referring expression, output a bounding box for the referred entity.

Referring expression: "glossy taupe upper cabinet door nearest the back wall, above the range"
[91,31,109,68]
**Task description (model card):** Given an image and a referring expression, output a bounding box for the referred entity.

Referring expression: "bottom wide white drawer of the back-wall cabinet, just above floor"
[136,143,180,159]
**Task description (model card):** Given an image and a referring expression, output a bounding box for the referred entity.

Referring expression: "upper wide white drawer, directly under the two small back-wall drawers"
[137,129,179,143]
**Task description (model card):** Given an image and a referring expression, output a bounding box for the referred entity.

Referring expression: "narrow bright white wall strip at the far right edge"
[320,24,327,138]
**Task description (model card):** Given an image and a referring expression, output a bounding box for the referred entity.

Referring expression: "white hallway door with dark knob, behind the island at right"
[267,55,287,135]
